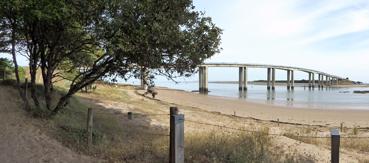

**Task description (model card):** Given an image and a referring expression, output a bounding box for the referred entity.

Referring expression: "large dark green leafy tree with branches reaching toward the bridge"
[0,0,221,115]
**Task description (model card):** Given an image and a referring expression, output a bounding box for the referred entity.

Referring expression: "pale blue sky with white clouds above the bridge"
[0,0,369,83]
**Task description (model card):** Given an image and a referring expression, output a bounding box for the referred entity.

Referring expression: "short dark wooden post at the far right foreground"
[331,128,340,163]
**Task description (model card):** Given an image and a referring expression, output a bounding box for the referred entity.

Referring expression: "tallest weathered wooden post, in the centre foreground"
[169,107,184,163]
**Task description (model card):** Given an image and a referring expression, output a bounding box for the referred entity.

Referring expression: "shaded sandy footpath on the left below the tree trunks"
[0,86,96,163]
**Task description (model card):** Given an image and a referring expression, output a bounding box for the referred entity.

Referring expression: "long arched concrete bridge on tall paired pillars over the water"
[198,63,345,92]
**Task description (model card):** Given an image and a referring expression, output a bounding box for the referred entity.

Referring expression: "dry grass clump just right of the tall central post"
[185,131,274,162]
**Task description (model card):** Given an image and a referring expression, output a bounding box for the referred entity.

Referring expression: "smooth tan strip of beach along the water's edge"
[153,89,369,127]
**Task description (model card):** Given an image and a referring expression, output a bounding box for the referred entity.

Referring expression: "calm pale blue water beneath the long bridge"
[153,82,369,110]
